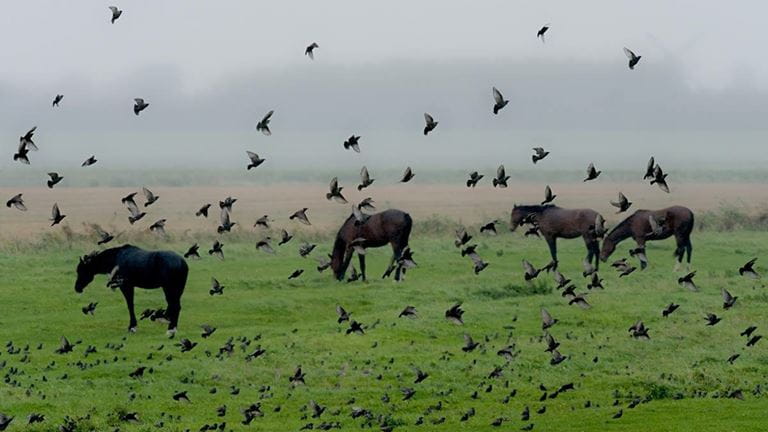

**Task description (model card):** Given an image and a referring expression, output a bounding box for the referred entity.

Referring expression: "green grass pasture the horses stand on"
[0,232,768,431]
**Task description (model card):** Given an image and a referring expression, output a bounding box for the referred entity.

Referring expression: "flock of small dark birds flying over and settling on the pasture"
[0,6,762,432]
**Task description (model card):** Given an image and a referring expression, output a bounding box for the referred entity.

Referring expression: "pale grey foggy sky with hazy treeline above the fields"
[0,0,768,172]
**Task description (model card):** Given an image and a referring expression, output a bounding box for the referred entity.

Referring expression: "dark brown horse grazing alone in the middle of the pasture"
[331,209,413,281]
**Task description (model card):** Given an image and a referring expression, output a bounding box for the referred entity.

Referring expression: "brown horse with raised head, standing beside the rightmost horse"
[510,205,602,269]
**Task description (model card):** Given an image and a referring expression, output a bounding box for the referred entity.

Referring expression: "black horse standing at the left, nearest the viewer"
[75,245,188,336]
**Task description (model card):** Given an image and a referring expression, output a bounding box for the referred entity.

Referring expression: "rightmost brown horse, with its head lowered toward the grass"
[600,206,694,269]
